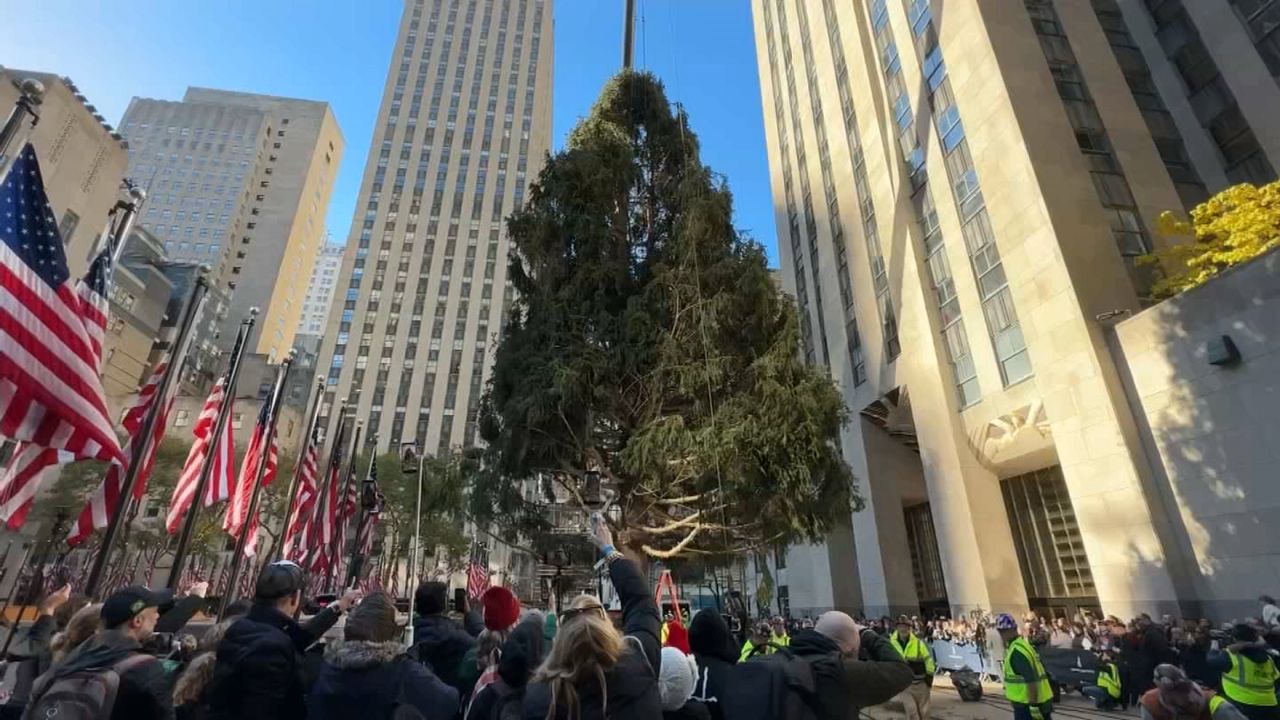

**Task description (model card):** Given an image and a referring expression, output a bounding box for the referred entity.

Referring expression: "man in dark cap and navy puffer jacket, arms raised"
[205,560,360,720]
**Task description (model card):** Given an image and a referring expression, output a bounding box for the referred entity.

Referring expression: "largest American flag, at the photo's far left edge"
[0,145,124,528]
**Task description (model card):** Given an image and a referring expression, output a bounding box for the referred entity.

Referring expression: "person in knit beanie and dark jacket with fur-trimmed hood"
[307,592,458,720]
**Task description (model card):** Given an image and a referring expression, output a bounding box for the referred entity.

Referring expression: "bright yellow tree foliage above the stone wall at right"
[1143,182,1280,297]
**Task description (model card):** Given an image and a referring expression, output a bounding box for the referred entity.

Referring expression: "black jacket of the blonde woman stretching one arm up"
[524,559,662,720]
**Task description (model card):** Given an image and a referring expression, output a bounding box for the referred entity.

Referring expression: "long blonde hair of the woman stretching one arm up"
[532,594,622,720]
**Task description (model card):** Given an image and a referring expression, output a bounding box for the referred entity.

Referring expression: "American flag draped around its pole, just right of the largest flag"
[67,359,178,546]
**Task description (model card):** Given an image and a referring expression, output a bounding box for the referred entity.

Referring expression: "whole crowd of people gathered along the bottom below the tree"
[0,532,1280,720]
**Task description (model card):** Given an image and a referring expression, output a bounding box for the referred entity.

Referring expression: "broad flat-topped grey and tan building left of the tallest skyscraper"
[120,87,343,360]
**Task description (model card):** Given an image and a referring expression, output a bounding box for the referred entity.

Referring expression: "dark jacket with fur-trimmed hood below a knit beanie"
[307,632,458,720]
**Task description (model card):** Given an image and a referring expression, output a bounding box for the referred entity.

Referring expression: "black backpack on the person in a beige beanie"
[718,646,818,720]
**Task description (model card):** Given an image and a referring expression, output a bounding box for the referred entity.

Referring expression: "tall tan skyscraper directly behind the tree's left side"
[320,0,552,454]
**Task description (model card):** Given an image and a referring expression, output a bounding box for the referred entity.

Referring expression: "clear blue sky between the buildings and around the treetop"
[0,0,777,264]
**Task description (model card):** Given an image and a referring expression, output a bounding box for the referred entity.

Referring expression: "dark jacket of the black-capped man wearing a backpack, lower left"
[37,630,173,720]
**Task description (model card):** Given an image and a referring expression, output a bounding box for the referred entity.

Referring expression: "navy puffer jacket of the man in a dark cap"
[205,605,338,720]
